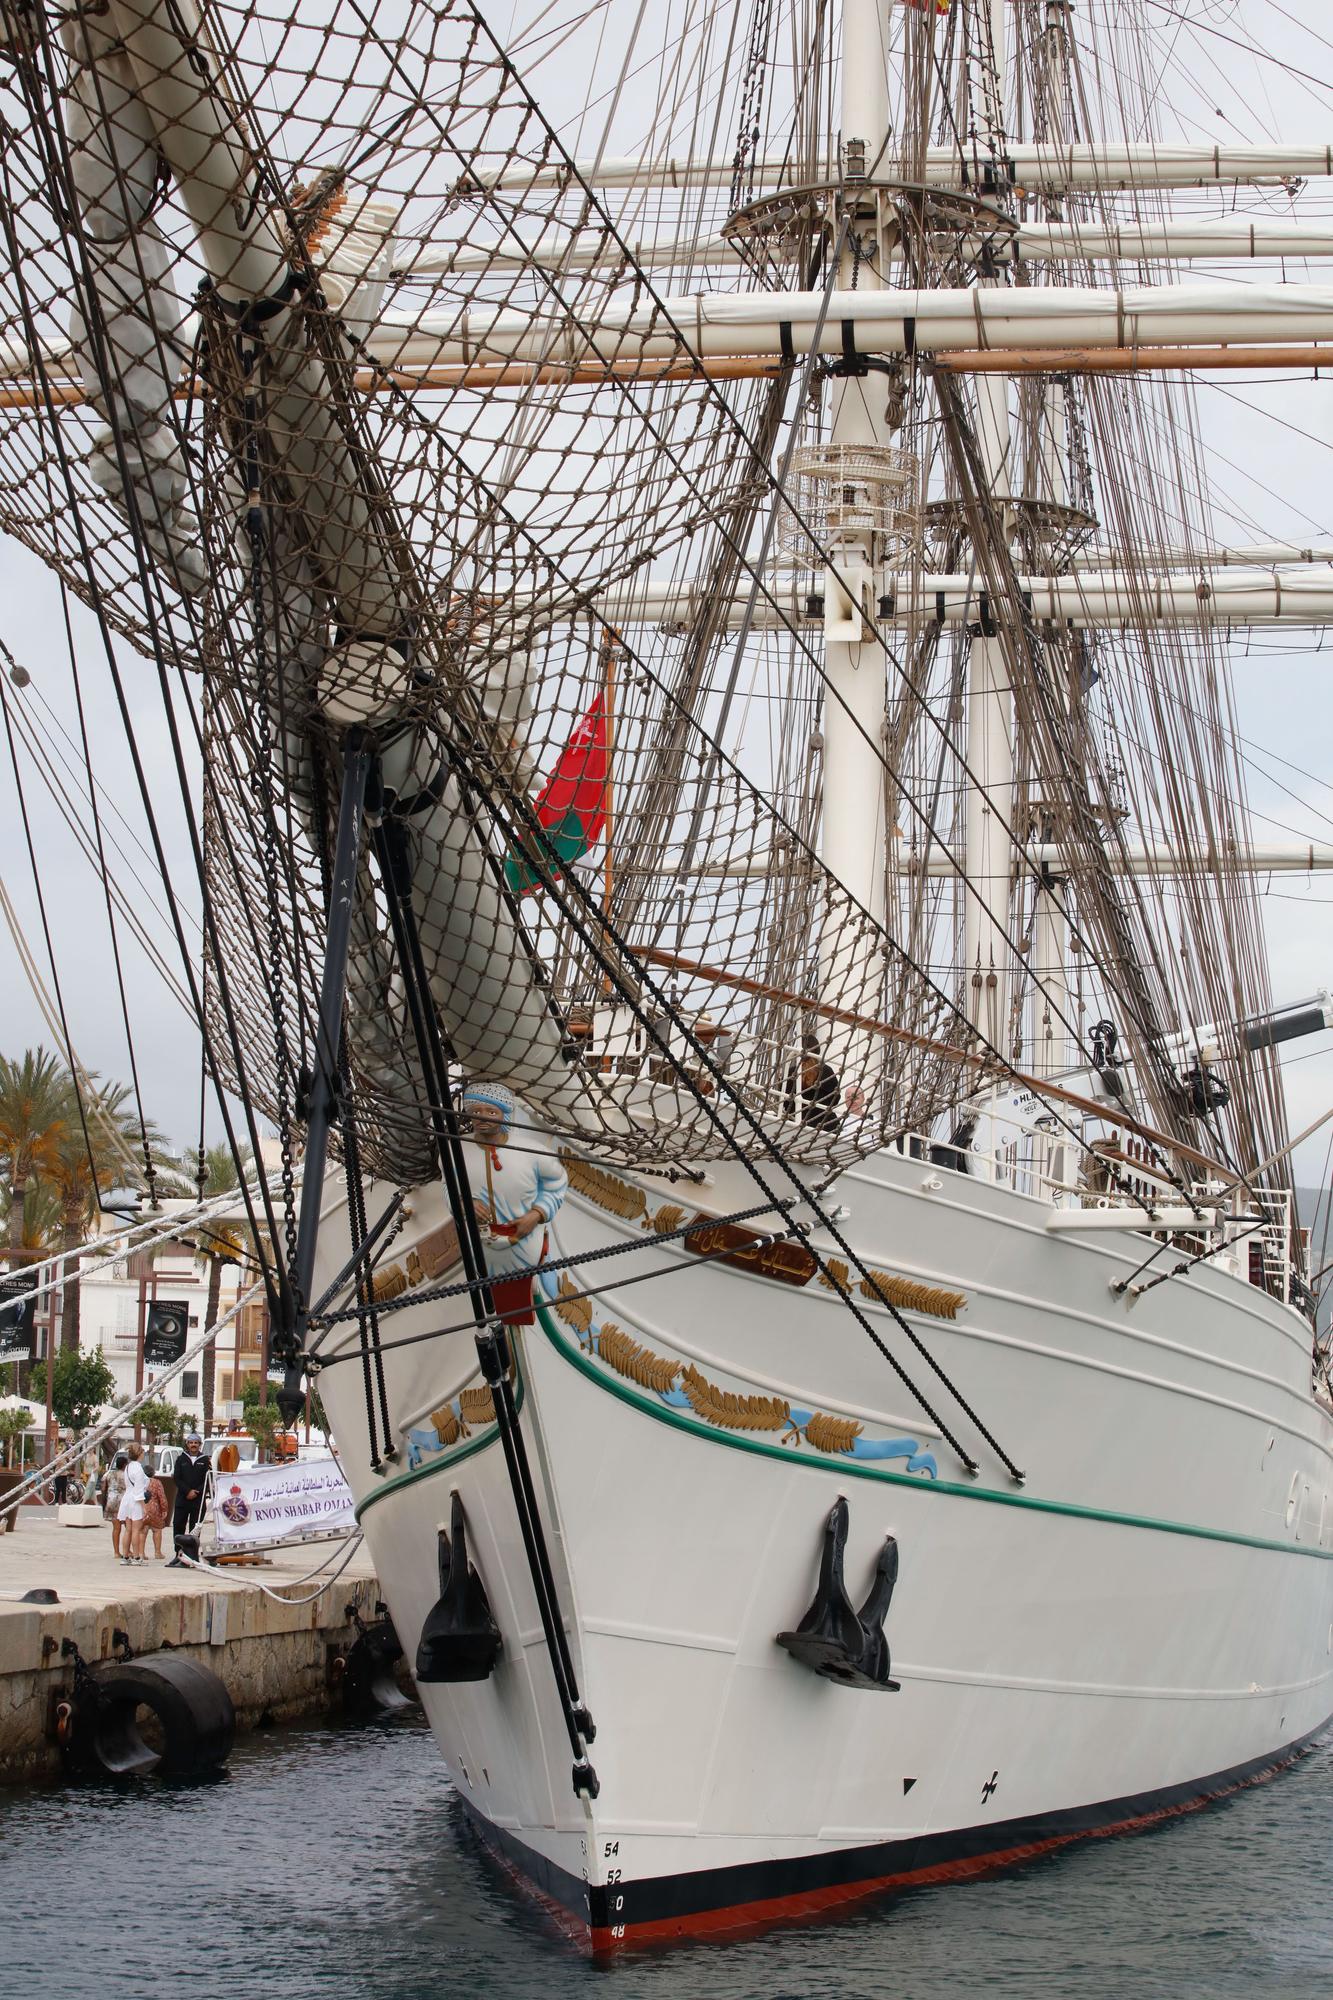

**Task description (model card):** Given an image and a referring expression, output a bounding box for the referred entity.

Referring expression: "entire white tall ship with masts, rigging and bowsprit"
[0,0,1333,1952]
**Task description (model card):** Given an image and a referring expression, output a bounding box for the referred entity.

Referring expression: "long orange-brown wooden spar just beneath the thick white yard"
[13,344,1333,410]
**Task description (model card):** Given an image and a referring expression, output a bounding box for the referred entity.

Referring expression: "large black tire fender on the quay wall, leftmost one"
[72,1652,236,1778]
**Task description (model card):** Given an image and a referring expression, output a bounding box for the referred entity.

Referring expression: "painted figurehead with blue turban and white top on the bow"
[462,1084,568,1326]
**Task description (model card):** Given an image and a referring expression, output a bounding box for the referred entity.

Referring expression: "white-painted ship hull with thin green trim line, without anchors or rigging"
[322,1156,1333,1948]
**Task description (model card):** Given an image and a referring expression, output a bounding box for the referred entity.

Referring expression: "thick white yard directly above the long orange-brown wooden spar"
[370,284,1333,370]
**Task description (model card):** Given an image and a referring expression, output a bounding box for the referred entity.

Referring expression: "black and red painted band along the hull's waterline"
[454,1722,1327,1958]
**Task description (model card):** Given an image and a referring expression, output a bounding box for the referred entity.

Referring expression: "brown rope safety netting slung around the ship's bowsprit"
[0,0,977,1180]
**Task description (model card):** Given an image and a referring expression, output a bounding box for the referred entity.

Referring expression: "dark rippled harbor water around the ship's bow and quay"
[0,1720,1333,2000]
